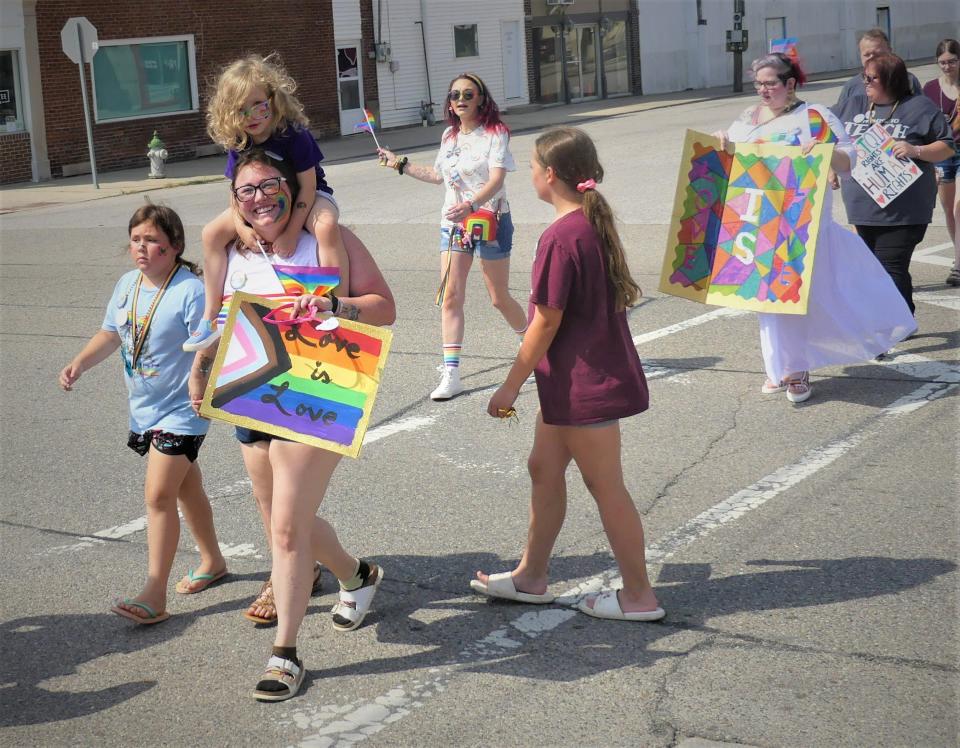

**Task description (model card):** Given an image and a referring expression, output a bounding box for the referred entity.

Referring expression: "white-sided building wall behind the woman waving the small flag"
[374,0,530,127]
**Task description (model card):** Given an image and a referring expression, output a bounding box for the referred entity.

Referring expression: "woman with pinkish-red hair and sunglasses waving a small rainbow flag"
[380,73,527,400]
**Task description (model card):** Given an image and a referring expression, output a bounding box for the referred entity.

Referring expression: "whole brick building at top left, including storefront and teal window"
[0,0,377,184]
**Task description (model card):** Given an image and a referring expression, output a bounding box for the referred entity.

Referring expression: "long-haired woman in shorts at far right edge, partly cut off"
[923,39,960,286]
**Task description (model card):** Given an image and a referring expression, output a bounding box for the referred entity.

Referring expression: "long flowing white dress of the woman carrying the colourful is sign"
[727,104,917,382]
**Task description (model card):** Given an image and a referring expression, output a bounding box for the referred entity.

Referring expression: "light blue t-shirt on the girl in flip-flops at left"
[102,266,210,434]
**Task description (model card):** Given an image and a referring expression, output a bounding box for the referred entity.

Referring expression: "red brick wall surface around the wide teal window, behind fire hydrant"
[37,0,340,176]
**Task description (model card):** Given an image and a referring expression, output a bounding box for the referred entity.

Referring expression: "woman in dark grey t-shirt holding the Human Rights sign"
[836,54,955,312]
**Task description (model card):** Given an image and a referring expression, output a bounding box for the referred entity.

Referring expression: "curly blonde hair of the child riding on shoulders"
[207,52,309,151]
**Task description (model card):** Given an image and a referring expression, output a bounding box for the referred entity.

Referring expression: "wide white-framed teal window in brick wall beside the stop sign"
[93,36,199,122]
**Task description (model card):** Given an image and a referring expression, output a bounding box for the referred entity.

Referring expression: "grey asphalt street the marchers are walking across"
[0,77,960,746]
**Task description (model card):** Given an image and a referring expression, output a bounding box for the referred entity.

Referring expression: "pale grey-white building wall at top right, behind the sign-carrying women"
[637,0,960,94]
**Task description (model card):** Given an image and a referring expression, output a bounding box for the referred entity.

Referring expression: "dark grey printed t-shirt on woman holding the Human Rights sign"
[834,94,953,226]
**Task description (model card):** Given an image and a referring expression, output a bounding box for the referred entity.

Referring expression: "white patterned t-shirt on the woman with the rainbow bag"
[433,127,517,227]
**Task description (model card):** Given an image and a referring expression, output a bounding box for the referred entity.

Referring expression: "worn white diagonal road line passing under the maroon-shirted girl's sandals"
[280,354,960,748]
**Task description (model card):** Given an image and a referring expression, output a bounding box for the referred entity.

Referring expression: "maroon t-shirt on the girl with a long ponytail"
[529,210,649,426]
